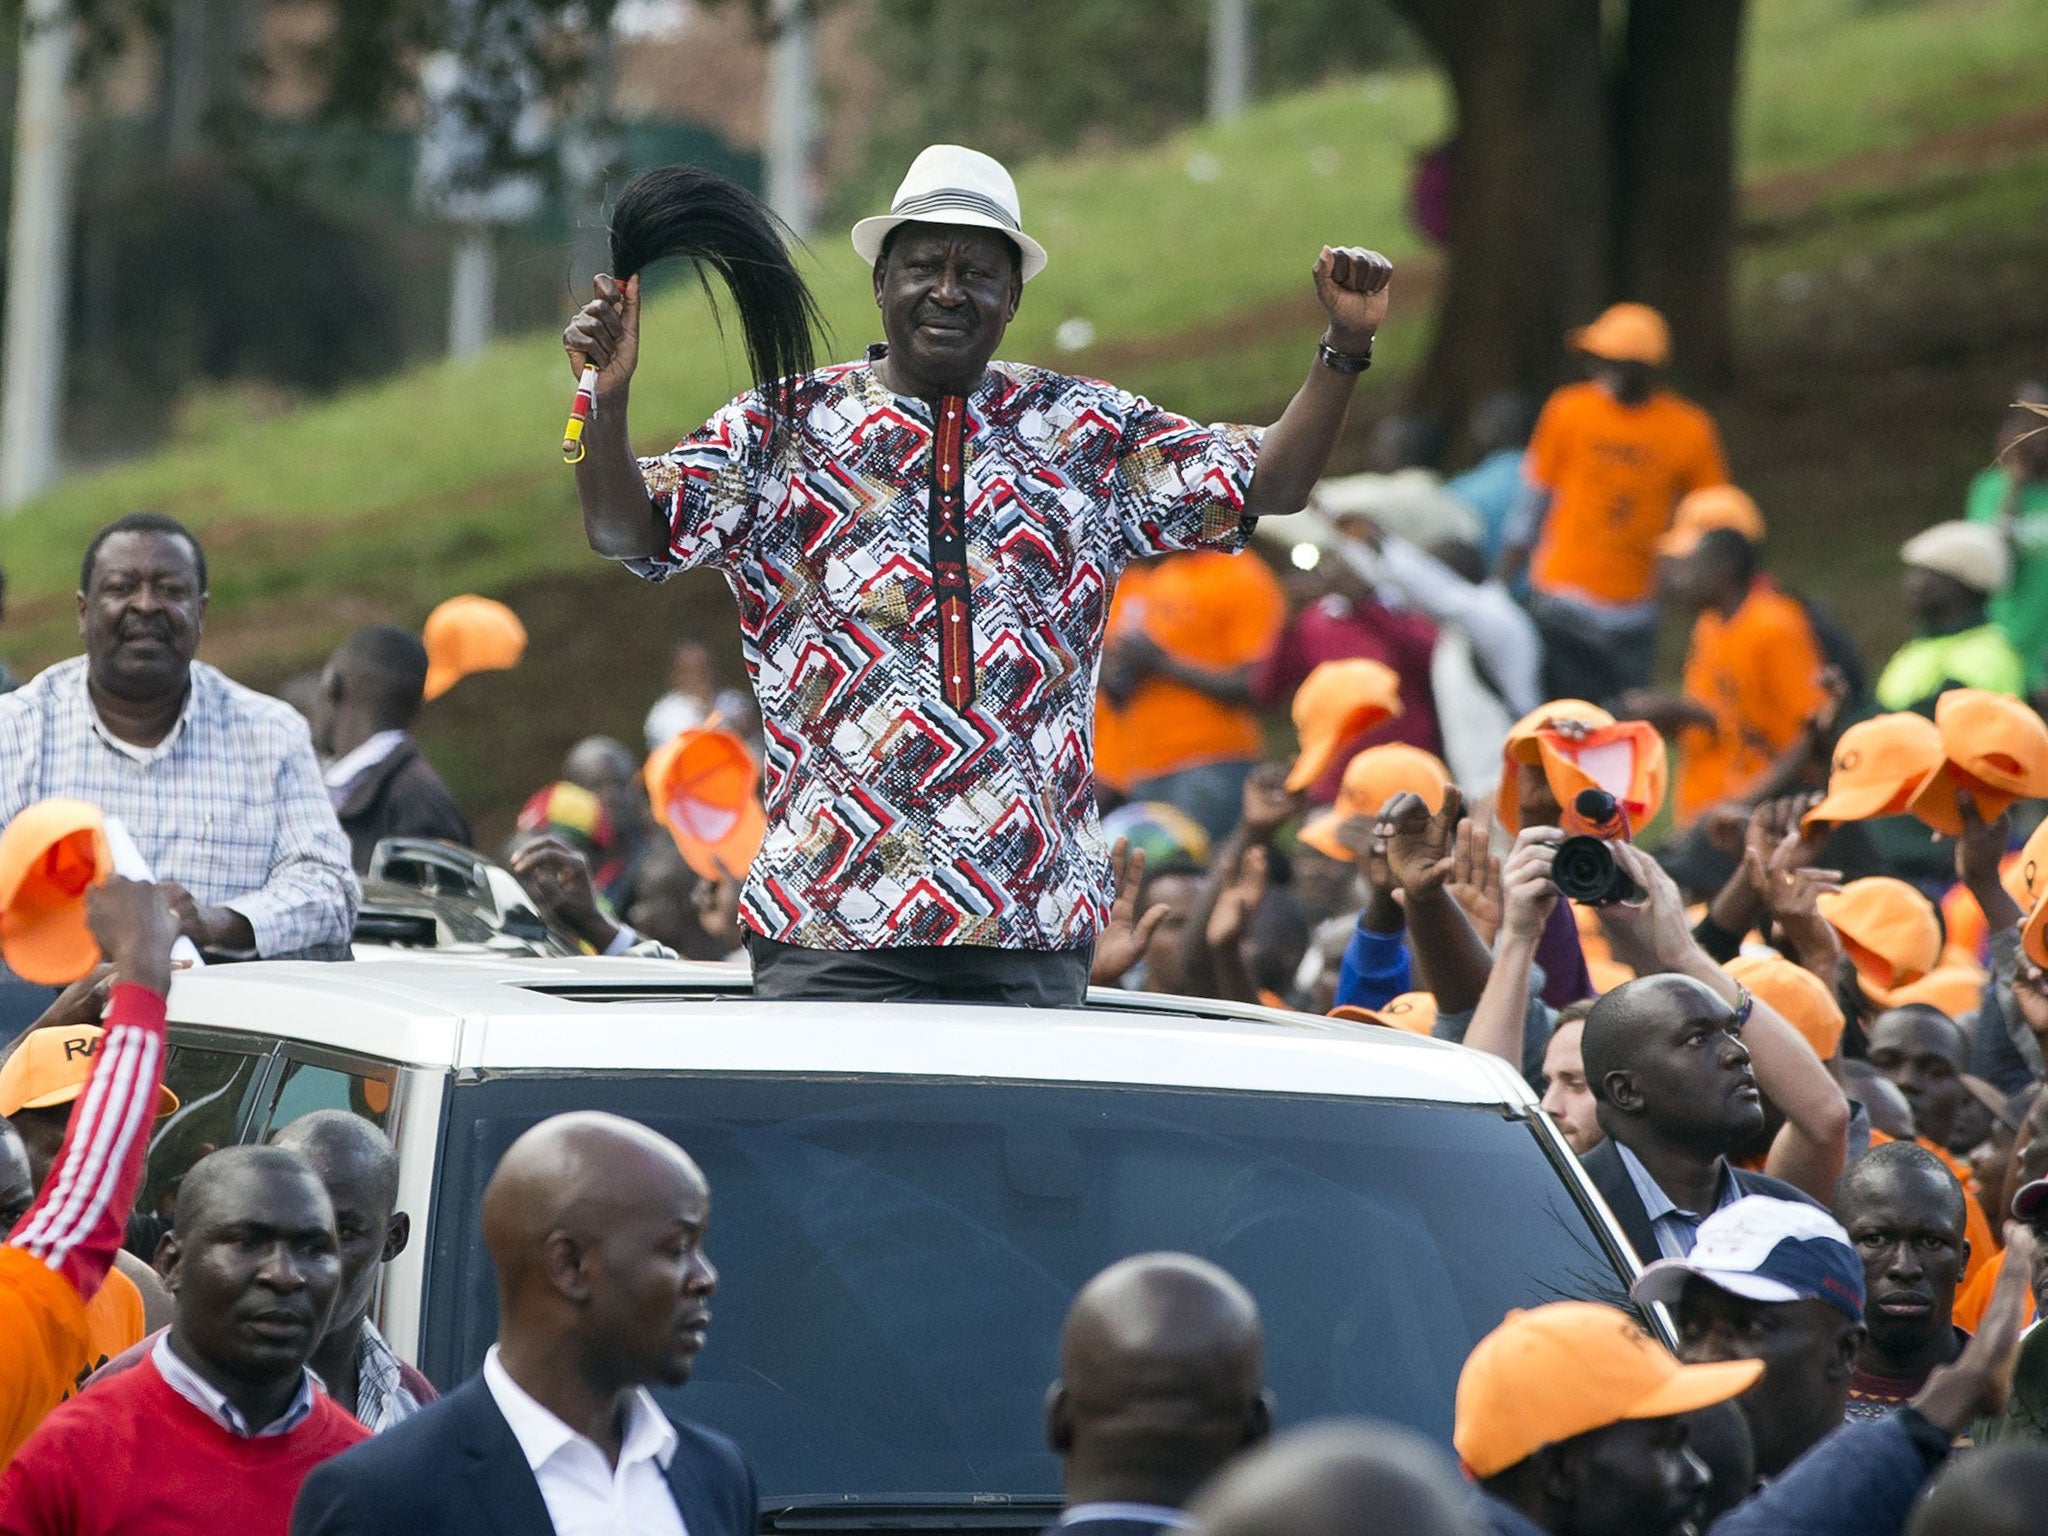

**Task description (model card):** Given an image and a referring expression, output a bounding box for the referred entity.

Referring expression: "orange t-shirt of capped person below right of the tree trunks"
[1675,578,1827,827]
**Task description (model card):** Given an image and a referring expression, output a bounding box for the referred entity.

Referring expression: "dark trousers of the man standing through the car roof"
[745,934,1096,1008]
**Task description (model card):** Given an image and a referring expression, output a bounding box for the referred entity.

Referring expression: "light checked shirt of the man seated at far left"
[0,655,360,956]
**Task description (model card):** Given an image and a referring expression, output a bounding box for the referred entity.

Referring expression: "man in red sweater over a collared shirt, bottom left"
[0,1147,369,1536]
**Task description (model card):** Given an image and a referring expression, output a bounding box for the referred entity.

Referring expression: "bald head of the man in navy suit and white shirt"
[483,1114,719,1393]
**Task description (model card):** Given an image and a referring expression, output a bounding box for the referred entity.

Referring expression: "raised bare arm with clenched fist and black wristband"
[1245,246,1395,518]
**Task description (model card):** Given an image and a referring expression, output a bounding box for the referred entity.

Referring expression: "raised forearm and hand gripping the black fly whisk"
[561,274,668,559]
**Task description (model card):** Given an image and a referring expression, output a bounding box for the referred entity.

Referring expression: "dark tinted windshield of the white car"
[422,1075,1626,1503]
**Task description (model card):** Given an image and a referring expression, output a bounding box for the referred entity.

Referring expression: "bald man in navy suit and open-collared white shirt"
[291,1114,760,1536]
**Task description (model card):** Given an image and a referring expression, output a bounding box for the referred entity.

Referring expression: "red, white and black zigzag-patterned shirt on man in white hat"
[631,352,1257,950]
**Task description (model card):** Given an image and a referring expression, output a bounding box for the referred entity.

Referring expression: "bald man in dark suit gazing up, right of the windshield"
[1579,973,1819,1264]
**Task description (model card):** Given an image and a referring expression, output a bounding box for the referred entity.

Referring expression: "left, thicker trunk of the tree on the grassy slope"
[1403,0,1612,432]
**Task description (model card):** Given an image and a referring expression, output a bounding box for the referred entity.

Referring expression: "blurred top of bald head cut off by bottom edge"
[1188,1419,1485,1536]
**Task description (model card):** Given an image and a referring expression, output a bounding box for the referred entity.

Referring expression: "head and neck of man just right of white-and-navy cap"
[1835,1141,1970,1419]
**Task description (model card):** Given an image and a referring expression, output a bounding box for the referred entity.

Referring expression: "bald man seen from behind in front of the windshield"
[1048,1253,1274,1536]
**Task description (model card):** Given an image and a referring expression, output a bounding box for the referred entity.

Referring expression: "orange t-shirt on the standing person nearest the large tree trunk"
[1522,383,1729,606]
